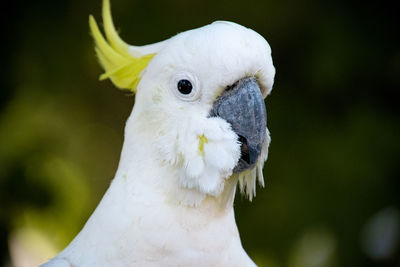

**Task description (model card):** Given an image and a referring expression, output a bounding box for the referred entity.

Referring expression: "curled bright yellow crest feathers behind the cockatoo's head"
[89,0,154,92]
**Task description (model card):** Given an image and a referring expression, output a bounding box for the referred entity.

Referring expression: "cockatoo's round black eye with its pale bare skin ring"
[171,71,200,102]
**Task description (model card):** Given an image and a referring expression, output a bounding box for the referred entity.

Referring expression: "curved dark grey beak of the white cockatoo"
[210,78,267,173]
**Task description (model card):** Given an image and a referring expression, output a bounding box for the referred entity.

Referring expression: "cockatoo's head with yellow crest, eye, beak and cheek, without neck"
[89,0,275,205]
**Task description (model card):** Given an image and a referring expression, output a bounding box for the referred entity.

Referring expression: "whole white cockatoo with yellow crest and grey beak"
[43,0,275,267]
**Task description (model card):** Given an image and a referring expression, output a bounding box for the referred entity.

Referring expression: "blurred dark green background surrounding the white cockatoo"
[0,0,400,267]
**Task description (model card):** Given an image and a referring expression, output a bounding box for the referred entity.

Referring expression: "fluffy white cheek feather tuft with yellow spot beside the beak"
[177,118,240,199]
